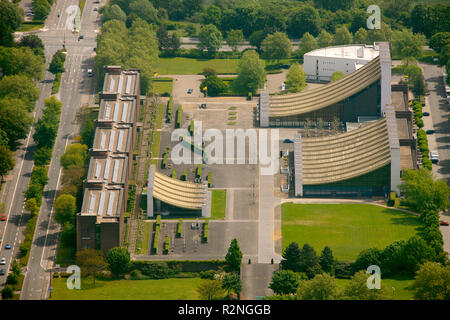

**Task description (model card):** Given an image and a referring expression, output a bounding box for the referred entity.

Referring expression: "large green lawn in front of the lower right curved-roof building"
[282,203,421,260]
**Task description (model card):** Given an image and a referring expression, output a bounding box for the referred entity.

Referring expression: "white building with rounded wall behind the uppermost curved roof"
[303,44,379,82]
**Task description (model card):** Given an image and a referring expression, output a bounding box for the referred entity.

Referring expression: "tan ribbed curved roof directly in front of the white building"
[269,57,381,117]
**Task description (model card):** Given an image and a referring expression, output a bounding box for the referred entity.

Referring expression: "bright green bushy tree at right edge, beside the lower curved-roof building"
[399,168,449,213]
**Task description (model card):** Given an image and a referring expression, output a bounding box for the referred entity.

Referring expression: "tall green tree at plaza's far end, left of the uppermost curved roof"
[233,50,266,94]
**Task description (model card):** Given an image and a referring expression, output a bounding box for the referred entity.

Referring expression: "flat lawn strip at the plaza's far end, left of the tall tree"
[155,57,239,74]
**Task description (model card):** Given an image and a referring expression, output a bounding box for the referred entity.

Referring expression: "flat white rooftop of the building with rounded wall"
[305,44,380,61]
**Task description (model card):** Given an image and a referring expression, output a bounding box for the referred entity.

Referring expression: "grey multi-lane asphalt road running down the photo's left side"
[11,0,100,300]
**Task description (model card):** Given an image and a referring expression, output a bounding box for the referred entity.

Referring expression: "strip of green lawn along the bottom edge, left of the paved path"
[51,278,204,300]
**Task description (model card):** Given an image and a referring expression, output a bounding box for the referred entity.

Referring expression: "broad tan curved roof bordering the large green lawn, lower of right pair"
[302,118,391,185]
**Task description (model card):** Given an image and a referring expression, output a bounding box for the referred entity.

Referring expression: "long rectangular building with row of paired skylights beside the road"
[76,66,141,254]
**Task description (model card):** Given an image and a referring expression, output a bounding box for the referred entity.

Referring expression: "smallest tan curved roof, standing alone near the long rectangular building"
[153,172,207,210]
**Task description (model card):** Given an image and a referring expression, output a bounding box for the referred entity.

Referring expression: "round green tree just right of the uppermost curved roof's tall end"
[392,29,426,59]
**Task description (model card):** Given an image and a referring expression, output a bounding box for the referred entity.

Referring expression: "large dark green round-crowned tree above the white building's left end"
[287,5,321,39]
